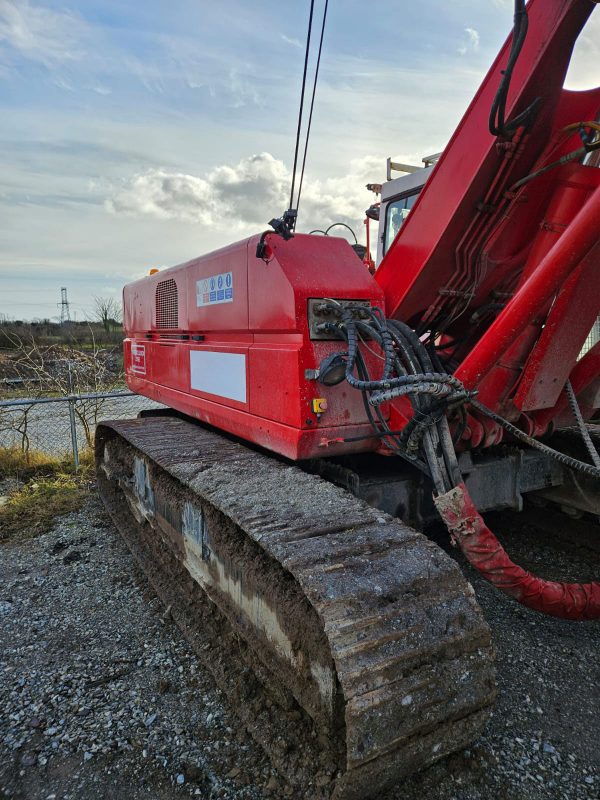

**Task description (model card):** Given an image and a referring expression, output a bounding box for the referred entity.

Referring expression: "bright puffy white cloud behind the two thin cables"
[106,153,382,241]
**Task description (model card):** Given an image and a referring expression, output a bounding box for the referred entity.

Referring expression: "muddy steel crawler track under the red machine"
[96,416,495,800]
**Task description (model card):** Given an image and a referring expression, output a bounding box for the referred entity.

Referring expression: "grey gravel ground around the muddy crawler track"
[0,495,600,800]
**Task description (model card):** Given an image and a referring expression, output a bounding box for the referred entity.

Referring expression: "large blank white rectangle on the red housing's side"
[190,350,247,403]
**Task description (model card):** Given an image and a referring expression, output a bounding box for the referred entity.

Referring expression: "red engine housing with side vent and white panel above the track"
[123,235,383,459]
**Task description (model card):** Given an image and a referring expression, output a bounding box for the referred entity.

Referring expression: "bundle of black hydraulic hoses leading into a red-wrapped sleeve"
[329,309,600,620]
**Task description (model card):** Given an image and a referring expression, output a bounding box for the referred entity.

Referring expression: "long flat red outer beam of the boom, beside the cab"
[376,0,597,322]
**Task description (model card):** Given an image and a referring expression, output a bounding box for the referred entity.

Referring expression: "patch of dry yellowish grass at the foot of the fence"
[0,448,93,542]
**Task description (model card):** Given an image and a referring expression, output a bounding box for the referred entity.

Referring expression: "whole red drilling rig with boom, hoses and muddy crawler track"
[96,0,600,800]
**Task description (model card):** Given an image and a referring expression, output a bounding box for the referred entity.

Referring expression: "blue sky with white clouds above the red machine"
[0,0,600,319]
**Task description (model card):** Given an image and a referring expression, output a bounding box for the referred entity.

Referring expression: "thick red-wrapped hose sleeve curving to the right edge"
[434,483,600,620]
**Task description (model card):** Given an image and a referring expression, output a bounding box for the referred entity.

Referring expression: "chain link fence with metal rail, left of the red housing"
[0,392,161,467]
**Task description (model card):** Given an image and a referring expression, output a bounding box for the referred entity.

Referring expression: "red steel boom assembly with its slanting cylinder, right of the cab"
[375,0,600,438]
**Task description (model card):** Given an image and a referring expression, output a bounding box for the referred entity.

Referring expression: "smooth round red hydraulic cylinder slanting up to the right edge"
[455,186,600,389]
